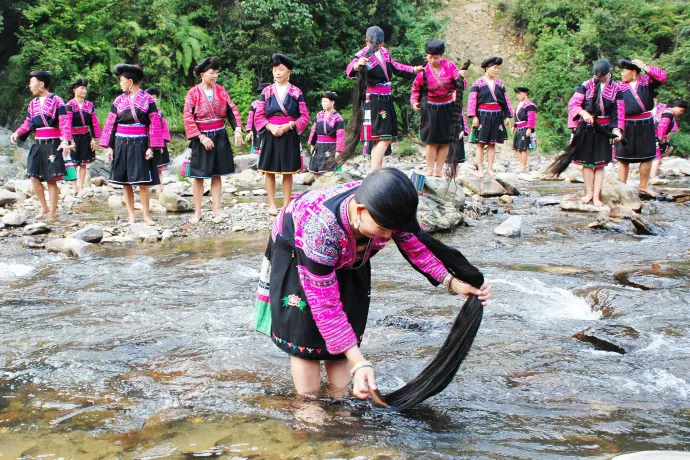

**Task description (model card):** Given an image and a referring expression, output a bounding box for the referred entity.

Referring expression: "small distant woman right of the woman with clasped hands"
[309,91,345,177]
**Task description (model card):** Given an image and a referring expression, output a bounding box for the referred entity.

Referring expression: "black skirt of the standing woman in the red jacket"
[189,128,235,179]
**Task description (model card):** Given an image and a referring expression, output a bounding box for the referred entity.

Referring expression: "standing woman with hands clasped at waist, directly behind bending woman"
[254,54,309,216]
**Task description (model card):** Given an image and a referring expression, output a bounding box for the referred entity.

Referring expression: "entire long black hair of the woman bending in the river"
[354,168,484,410]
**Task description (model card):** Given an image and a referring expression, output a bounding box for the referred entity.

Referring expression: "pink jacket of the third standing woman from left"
[98,90,165,149]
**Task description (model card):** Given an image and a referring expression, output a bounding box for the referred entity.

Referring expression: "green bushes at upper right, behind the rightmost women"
[512,0,690,155]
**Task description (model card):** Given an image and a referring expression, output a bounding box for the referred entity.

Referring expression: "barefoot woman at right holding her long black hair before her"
[568,59,625,206]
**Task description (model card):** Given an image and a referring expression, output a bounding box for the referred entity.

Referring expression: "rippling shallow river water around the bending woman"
[0,183,690,459]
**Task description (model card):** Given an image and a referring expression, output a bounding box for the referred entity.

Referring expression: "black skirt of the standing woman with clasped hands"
[257,129,302,174]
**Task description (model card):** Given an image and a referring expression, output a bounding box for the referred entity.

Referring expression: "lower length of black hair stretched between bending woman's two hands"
[374,295,484,411]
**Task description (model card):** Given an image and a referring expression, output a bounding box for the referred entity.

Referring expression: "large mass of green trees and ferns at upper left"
[0,0,443,140]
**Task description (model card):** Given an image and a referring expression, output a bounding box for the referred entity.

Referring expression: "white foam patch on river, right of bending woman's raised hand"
[491,278,601,321]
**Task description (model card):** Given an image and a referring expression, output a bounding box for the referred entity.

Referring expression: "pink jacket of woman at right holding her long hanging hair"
[568,78,625,130]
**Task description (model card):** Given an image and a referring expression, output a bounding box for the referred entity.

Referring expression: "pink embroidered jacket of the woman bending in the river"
[268,181,448,354]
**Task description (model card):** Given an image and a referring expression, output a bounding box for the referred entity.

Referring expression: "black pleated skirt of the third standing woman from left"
[109,136,160,185]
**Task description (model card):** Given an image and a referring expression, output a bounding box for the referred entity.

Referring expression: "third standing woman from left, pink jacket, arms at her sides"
[99,64,165,223]
